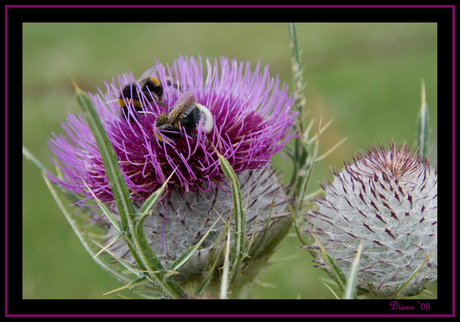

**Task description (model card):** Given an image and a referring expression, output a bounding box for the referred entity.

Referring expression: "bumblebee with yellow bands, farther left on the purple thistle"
[118,65,174,119]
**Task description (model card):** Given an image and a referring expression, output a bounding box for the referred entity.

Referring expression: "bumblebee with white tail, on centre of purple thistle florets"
[155,91,214,142]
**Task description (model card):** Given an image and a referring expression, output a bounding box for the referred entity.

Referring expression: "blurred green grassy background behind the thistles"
[23,23,437,299]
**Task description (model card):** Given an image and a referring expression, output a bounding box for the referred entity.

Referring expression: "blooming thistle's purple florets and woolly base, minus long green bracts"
[48,57,296,282]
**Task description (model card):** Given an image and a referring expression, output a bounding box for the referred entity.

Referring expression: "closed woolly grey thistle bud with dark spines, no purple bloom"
[304,143,437,298]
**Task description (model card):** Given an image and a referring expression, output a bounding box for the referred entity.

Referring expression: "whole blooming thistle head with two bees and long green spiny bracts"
[37,57,296,298]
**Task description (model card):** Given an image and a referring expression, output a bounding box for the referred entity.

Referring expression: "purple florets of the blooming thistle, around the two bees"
[48,56,296,204]
